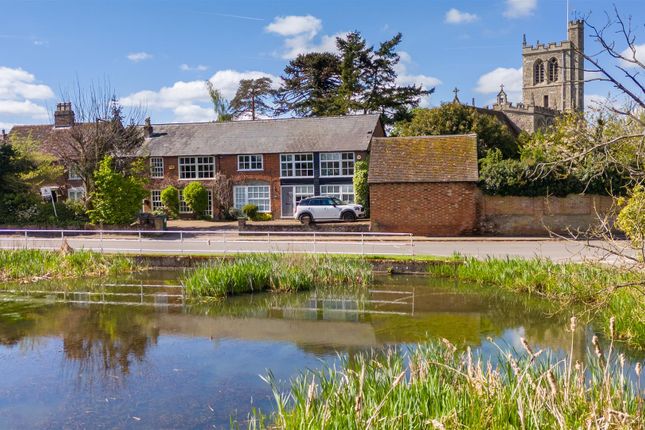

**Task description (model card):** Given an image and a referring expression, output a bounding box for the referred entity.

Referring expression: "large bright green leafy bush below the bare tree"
[88,157,148,225]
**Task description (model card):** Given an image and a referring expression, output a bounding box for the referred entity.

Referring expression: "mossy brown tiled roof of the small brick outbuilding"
[368,134,479,184]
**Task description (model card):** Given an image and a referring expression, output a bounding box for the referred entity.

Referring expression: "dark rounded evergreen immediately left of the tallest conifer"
[275,52,340,117]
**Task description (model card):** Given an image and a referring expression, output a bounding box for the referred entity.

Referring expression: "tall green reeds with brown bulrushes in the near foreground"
[244,320,645,430]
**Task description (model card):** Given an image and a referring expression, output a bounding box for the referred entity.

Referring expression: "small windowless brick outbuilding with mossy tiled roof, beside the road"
[368,134,478,236]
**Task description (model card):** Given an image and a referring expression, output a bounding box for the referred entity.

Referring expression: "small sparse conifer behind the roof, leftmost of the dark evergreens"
[229,77,274,120]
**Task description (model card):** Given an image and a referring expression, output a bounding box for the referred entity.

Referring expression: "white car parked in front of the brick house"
[293,196,365,224]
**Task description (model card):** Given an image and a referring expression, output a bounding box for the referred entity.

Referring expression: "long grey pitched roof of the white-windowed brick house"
[143,114,380,157]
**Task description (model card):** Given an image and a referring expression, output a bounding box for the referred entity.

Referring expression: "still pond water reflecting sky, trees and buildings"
[0,272,643,429]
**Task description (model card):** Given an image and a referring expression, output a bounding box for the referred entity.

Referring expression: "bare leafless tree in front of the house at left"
[53,83,144,200]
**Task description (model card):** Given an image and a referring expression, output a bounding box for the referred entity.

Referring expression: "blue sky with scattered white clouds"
[0,0,645,130]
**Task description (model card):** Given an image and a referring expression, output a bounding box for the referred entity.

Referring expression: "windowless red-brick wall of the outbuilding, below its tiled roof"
[370,182,478,236]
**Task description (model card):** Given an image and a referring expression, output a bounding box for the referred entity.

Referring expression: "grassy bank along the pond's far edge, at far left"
[0,249,136,282]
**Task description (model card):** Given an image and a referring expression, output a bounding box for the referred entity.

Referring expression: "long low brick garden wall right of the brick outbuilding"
[479,194,614,236]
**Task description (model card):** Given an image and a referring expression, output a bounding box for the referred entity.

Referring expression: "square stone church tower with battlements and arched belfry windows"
[522,20,584,112]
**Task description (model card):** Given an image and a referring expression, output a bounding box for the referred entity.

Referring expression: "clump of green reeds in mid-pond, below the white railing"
[182,254,372,297]
